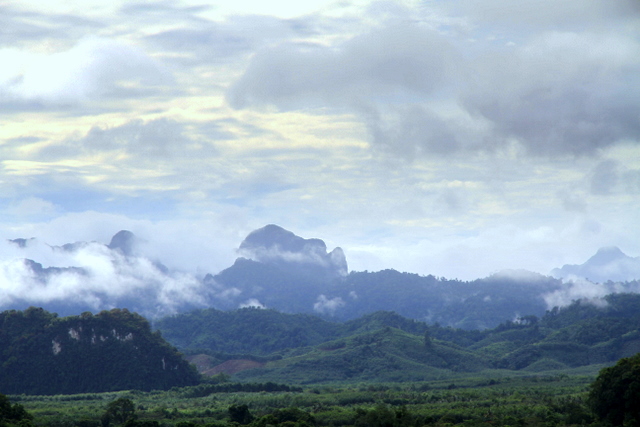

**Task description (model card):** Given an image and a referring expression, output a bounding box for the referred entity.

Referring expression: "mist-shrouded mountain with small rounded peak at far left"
[0,230,211,317]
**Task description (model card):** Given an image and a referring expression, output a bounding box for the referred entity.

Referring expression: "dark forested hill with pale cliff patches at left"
[0,307,199,394]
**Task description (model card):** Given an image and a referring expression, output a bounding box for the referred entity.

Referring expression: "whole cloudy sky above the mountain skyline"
[0,0,640,280]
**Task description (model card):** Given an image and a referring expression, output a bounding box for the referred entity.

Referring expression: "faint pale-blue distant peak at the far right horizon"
[551,246,640,283]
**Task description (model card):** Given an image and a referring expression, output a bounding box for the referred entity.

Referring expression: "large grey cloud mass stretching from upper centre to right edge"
[227,12,640,158]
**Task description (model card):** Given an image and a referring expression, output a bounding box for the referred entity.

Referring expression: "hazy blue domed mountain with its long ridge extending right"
[211,225,562,329]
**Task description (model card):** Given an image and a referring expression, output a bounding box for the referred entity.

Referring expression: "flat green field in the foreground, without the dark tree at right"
[11,375,597,427]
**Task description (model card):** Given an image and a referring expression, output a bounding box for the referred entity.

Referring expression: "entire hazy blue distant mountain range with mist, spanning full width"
[0,224,640,330]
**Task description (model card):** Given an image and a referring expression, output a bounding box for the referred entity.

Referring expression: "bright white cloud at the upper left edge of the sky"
[0,37,172,107]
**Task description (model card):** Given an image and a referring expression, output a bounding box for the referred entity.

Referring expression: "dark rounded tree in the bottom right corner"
[588,353,640,426]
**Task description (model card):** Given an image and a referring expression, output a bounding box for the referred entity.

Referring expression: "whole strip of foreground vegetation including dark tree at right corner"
[12,353,640,427]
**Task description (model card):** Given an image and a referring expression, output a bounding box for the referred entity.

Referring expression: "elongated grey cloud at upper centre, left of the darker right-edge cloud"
[227,26,456,109]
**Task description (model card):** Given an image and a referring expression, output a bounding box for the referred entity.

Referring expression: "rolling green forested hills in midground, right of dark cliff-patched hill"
[156,294,640,383]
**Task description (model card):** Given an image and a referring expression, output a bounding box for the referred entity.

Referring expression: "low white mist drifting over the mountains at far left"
[0,237,198,315]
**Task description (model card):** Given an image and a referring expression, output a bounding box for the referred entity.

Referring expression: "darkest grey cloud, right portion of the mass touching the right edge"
[462,32,640,155]
